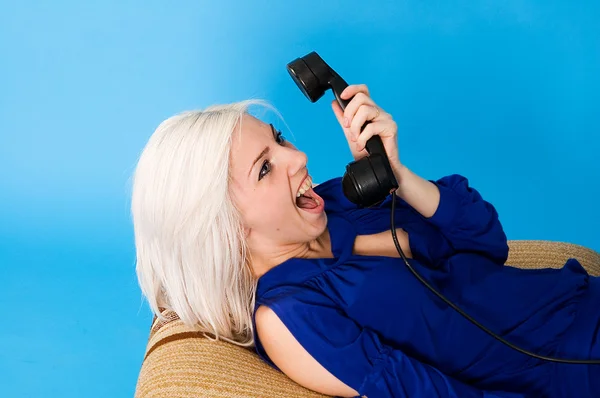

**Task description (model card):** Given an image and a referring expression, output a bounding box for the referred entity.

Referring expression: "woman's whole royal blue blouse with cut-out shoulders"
[255,175,600,398]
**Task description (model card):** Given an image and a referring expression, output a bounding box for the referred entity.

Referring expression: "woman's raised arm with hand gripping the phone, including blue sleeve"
[332,85,508,264]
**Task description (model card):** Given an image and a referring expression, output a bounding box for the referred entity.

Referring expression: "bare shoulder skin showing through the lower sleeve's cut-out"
[255,305,358,397]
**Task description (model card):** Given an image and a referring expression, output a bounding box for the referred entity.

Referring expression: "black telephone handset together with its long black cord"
[287,51,600,365]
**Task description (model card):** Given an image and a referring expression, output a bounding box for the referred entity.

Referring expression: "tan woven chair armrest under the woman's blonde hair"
[135,313,326,398]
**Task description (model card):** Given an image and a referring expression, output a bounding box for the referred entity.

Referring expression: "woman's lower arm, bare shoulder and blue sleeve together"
[256,306,521,398]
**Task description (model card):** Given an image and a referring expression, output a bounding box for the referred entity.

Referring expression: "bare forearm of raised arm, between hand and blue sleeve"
[393,165,440,218]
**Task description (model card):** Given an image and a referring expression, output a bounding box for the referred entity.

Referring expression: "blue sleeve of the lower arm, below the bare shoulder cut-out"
[266,295,523,398]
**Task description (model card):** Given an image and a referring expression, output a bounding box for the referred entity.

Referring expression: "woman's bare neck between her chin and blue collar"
[250,229,333,278]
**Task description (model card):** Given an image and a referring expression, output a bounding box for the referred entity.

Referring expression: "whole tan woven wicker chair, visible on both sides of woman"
[135,240,600,398]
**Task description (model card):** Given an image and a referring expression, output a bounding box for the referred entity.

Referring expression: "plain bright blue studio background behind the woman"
[0,0,600,398]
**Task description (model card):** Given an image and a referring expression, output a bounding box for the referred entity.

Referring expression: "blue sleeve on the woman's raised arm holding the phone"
[323,174,508,265]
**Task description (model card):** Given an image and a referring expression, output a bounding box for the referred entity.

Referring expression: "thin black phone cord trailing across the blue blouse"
[391,191,600,365]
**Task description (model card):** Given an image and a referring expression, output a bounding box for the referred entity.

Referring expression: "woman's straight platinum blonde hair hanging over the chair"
[131,100,277,346]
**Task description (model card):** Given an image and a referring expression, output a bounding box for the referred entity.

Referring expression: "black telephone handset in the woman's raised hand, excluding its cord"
[287,51,398,207]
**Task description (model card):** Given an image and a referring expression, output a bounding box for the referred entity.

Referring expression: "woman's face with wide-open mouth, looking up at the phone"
[230,115,327,255]
